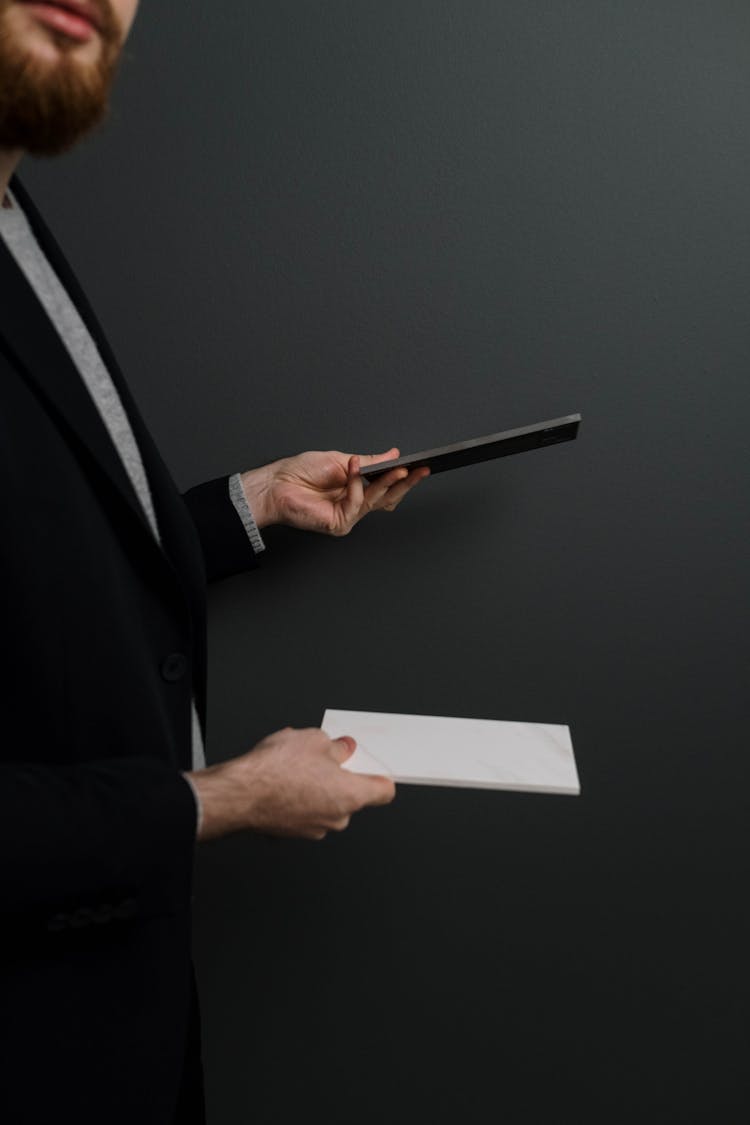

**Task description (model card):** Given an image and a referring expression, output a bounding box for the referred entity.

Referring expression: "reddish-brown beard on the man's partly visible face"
[0,0,121,156]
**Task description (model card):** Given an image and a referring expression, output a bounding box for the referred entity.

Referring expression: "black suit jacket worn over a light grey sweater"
[0,180,255,1125]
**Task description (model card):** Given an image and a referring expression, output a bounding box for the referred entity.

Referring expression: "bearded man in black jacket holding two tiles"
[0,0,427,1125]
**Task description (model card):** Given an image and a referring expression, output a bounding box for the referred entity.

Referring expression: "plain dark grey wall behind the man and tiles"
[26,0,750,1125]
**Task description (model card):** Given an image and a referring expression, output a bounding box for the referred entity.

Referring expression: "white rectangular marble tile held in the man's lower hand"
[320,710,580,794]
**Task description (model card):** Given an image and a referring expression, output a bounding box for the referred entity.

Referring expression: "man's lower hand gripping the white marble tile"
[186,727,396,840]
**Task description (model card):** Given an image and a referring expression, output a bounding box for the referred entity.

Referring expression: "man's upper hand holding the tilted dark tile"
[242,448,430,536]
